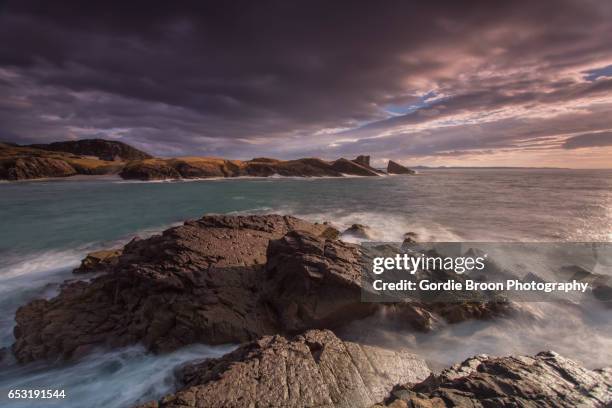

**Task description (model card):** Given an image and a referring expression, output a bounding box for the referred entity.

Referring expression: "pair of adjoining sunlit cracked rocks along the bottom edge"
[139,330,612,408]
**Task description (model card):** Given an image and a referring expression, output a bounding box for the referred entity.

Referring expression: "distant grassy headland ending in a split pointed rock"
[0,139,415,180]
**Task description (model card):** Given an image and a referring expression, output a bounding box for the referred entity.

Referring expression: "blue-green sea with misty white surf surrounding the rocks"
[0,169,612,408]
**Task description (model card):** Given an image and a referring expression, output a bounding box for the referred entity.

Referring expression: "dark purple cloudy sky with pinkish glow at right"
[0,0,612,168]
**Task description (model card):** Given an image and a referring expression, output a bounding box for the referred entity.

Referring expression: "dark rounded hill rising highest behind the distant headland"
[30,139,151,161]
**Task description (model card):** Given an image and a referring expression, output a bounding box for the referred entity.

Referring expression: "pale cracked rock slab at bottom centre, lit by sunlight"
[141,330,430,408]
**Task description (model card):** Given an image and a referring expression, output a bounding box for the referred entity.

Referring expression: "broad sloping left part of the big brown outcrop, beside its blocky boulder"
[13,215,327,361]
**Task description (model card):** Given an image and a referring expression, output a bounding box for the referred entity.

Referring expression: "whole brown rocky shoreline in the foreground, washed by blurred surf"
[4,215,612,408]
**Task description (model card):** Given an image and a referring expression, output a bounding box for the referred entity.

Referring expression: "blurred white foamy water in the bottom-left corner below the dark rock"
[0,345,235,408]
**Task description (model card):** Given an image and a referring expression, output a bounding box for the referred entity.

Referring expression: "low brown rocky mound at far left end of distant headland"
[0,157,77,180]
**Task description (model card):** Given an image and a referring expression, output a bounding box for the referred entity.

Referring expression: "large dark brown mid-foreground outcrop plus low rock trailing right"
[12,215,516,362]
